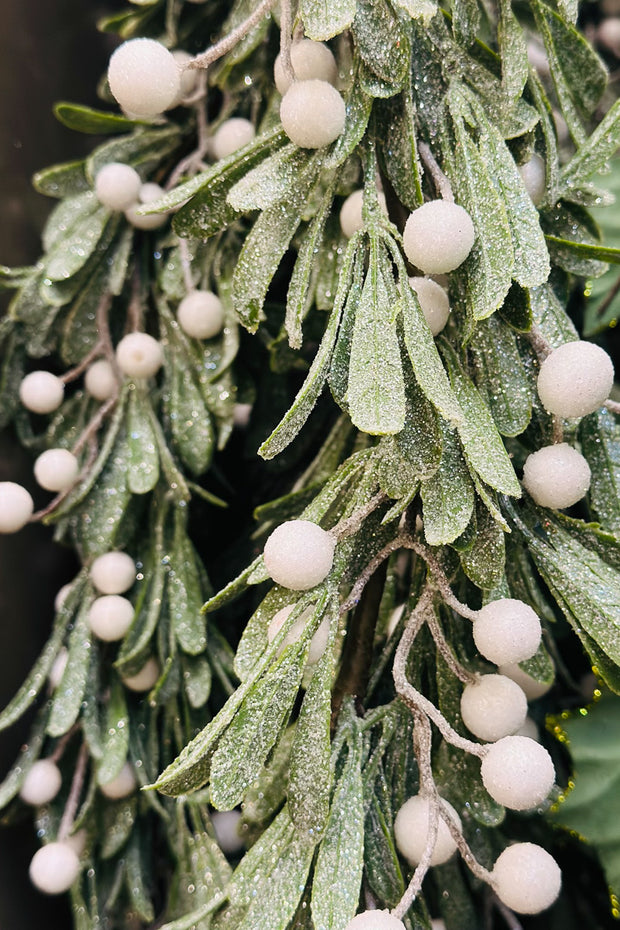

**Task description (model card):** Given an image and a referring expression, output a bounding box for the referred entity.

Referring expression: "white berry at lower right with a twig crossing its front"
[394,794,461,865]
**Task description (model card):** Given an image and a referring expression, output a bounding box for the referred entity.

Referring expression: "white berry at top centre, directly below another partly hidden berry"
[280,80,346,149]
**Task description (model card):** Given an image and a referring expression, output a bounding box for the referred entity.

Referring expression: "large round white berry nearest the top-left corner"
[108,39,181,116]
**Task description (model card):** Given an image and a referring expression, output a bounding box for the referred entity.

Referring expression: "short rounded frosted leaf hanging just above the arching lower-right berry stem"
[420,425,474,546]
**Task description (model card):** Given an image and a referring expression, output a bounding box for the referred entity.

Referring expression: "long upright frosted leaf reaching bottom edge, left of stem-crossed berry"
[312,730,364,930]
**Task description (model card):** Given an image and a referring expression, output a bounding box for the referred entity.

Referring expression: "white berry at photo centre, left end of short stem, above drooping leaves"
[263,520,336,591]
